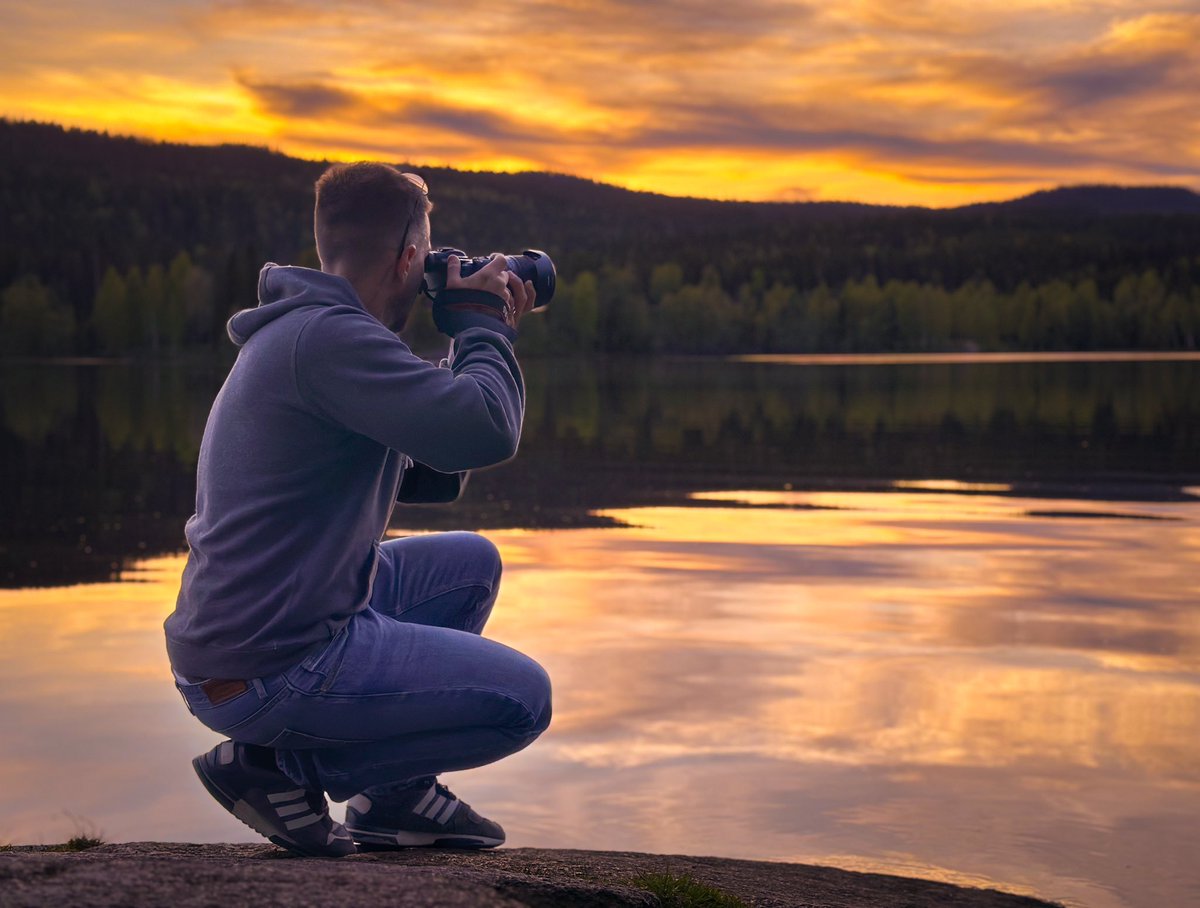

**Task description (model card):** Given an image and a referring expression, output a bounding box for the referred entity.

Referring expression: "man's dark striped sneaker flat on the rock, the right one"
[346,777,504,848]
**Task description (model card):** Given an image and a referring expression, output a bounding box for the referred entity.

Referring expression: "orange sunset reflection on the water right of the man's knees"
[477,492,1200,907]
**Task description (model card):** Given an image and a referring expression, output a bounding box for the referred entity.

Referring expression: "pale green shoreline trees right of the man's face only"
[350,261,1200,354]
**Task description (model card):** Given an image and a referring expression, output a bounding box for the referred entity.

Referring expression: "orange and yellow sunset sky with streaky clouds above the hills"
[0,0,1200,206]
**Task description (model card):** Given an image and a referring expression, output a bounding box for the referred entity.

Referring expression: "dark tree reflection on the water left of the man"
[0,363,216,585]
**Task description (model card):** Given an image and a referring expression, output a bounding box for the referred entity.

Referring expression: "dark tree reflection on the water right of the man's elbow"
[524,360,1200,477]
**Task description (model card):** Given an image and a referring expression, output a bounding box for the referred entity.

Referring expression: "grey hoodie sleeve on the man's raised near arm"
[294,307,524,473]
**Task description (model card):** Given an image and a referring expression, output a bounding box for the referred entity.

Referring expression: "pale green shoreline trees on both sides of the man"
[0,252,1200,356]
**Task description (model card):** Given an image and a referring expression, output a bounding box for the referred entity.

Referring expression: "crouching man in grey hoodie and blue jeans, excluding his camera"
[166,163,551,856]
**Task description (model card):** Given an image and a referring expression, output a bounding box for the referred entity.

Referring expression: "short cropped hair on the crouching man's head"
[313,161,433,267]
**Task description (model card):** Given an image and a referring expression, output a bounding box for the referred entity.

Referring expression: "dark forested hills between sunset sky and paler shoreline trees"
[0,119,1200,331]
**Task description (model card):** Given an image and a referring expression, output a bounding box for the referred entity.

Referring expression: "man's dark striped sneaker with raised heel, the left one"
[192,741,358,858]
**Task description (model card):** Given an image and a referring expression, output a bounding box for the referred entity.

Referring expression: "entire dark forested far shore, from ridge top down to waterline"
[0,120,1200,355]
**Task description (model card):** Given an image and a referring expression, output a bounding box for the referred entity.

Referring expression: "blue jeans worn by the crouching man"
[179,533,551,801]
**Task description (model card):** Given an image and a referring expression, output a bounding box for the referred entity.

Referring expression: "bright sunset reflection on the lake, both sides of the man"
[0,489,1200,908]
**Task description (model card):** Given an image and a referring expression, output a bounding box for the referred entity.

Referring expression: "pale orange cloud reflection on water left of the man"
[0,558,229,842]
